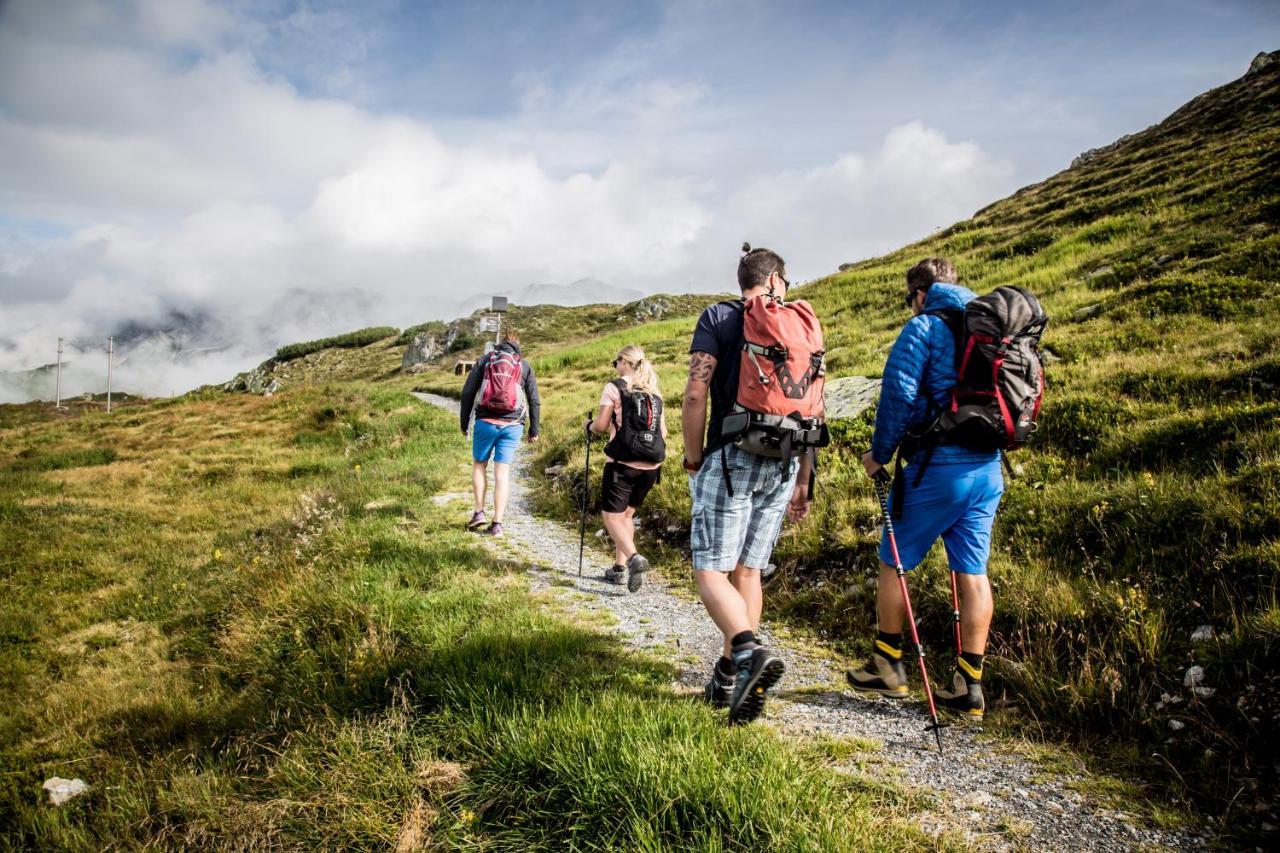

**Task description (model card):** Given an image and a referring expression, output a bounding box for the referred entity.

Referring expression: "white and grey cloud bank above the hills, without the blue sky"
[0,0,1011,400]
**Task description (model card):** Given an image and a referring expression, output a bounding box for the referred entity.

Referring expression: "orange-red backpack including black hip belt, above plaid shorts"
[721,295,831,494]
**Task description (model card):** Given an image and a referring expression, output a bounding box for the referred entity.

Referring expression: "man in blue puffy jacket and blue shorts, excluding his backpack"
[846,257,1005,719]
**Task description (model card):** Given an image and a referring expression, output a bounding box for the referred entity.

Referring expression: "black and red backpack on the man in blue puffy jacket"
[893,286,1048,515]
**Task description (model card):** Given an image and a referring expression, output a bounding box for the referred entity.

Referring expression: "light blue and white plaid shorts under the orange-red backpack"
[689,444,800,571]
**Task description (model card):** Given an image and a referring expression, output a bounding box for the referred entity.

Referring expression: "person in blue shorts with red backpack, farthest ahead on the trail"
[461,329,541,537]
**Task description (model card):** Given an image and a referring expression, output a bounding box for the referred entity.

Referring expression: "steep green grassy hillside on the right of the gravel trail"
[412,51,1280,820]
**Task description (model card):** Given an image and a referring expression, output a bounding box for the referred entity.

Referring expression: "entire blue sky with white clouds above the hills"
[0,0,1280,393]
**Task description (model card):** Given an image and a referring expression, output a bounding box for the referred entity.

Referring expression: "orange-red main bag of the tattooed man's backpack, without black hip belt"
[737,295,826,418]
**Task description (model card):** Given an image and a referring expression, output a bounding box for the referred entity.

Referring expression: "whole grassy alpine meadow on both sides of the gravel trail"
[0,34,1280,850]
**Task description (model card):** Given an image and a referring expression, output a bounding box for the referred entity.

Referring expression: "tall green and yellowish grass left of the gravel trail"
[0,386,946,850]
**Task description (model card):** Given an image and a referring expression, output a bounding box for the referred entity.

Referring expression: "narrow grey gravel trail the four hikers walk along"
[415,393,1211,850]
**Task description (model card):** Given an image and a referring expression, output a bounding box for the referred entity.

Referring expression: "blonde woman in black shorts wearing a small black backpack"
[586,343,667,592]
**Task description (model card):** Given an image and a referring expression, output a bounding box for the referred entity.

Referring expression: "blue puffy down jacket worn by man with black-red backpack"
[872,282,1000,465]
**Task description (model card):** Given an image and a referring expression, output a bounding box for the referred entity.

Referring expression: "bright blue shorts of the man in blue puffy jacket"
[879,456,1005,575]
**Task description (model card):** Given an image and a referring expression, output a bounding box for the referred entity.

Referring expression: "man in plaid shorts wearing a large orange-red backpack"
[681,245,826,722]
